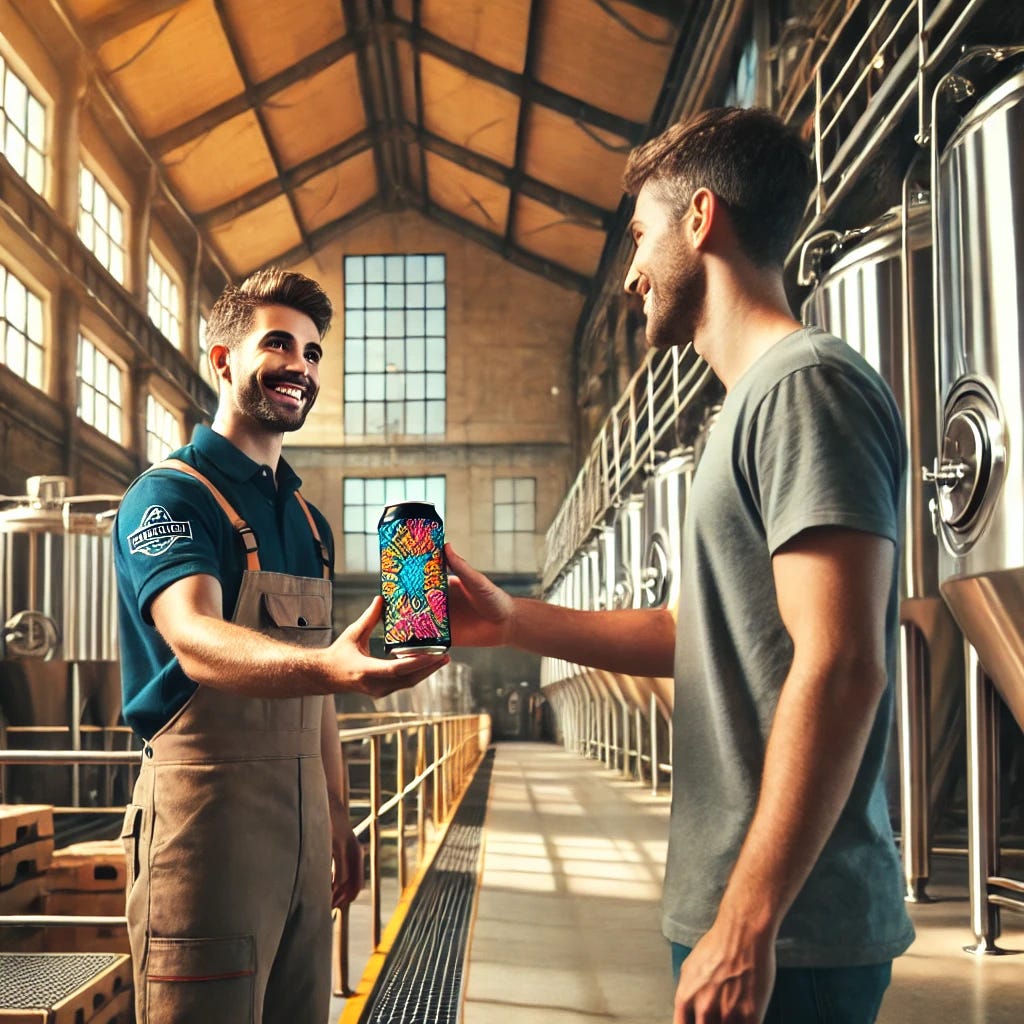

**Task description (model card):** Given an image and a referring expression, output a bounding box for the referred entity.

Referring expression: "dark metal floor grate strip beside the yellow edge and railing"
[359,750,495,1024]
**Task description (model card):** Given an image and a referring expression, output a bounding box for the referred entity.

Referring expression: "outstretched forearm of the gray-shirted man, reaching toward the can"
[509,598,676,676]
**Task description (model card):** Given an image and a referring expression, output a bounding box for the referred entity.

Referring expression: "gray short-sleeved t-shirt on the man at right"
[663,328,913,967]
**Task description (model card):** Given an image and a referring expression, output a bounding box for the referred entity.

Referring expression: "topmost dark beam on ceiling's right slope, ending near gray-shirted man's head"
[387,17,646,145]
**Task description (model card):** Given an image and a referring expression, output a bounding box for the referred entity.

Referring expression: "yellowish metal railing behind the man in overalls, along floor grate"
[0,714,490,995]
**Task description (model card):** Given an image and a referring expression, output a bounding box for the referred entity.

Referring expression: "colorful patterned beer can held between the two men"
[378,510,452,652]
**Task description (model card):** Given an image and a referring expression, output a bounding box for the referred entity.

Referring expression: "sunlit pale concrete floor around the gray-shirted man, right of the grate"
[463,743,1024,1024]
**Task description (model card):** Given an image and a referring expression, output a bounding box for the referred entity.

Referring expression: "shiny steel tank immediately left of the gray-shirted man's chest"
[640,447,694,608]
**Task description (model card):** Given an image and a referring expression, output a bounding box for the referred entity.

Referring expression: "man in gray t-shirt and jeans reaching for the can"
[449,109,913,1024]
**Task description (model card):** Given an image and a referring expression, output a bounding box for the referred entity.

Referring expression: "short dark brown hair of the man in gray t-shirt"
[623,106,813,266]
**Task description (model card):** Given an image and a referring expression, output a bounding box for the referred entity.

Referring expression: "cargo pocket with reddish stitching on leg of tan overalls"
[145,935,256,1024]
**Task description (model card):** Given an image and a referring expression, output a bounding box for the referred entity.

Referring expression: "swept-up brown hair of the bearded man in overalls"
[206,267,334,348]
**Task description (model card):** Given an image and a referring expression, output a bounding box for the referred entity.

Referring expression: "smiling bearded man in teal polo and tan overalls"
[115,269,446,1024]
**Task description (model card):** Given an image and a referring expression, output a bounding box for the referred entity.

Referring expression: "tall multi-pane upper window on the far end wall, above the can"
[345,255,445,436]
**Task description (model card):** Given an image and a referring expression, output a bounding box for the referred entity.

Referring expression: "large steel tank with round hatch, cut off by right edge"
[935,73,1024,728]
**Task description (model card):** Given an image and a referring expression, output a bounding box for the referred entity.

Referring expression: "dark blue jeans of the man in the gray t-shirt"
[672,942,893,1024]
